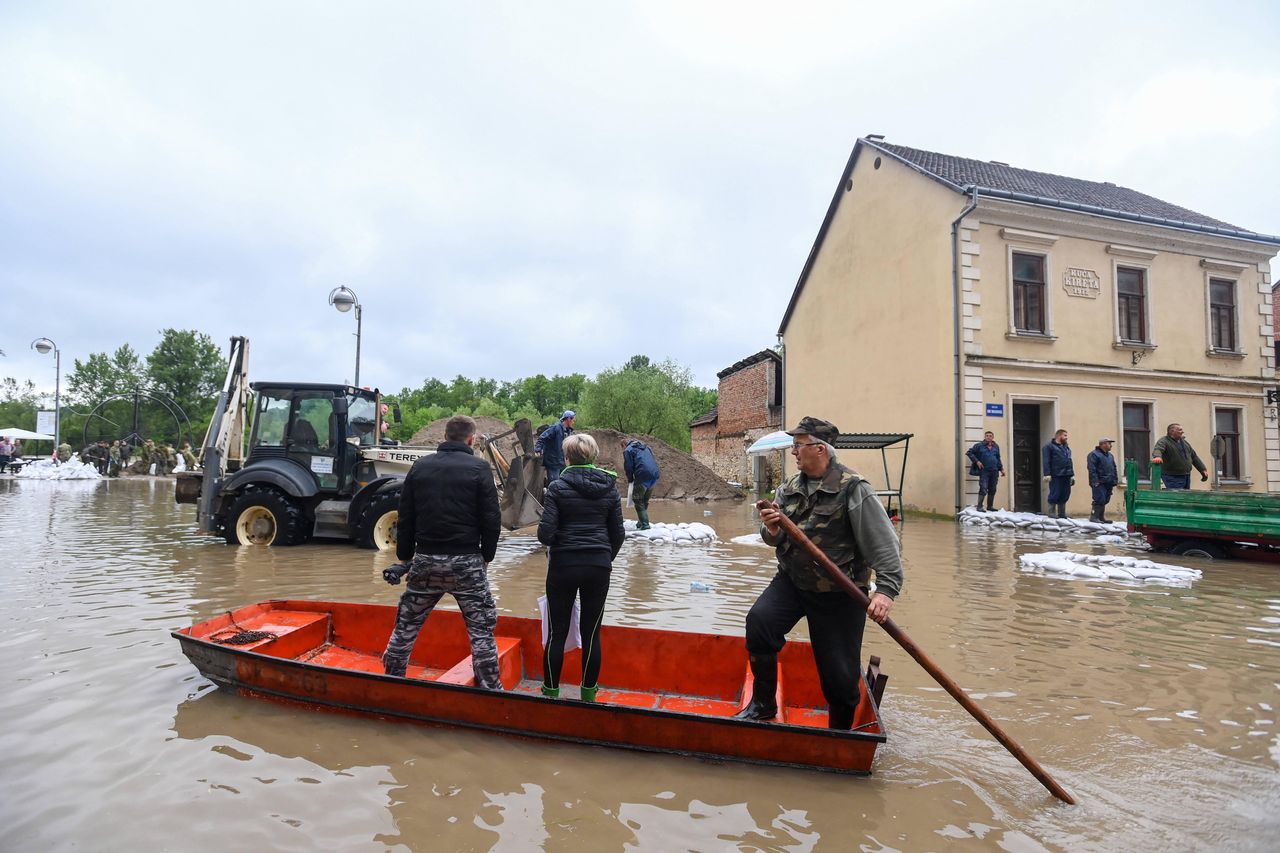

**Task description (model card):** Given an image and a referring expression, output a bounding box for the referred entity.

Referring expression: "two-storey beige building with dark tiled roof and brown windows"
[780,136,1280,514]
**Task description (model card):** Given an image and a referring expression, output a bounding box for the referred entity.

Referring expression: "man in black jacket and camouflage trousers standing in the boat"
[383,415,502,690]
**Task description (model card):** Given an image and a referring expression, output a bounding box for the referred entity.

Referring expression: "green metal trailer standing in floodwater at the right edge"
[1124,460,1280,562]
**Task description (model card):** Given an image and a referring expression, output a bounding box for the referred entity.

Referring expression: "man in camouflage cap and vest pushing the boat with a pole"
[737,418,902,729]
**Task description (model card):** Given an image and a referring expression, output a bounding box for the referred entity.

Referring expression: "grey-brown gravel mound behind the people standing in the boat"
[407,416,744,501]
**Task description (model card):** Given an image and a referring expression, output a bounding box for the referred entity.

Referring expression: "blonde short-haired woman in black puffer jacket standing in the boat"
[538,433,626,702]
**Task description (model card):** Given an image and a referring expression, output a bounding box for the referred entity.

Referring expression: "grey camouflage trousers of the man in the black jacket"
[383,553,502,690]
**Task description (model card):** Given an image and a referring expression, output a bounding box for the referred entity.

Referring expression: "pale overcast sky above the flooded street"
[0,0,1280,392]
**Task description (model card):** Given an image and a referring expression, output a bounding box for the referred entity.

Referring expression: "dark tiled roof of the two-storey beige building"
[868,140,1244,231]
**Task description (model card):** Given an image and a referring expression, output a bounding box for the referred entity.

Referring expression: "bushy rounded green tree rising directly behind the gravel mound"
[577,356,707,451]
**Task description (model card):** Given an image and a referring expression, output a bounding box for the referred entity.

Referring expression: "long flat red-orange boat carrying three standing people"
[173,601,887,774]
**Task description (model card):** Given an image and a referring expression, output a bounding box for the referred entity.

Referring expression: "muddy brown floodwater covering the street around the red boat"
[0,476,1280,850]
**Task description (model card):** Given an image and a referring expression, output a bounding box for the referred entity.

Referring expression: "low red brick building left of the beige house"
[690,350,782,488]
